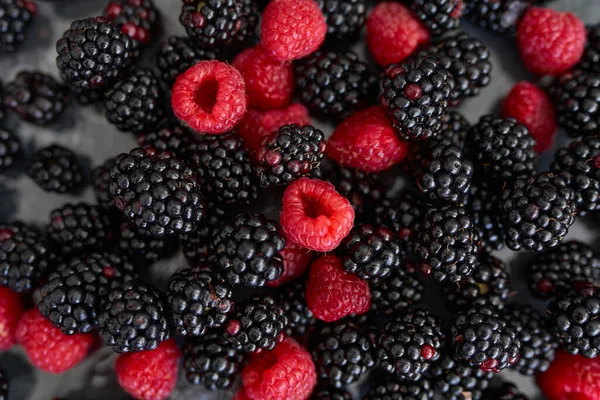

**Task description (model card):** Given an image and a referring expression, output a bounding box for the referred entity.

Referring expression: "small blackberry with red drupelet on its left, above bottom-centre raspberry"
[225,296,288,353]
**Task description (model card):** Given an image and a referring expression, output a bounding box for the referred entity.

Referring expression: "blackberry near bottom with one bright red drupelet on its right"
[377,308,446,381]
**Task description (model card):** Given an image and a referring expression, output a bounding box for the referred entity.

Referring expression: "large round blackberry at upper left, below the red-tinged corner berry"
[56,17,133,92]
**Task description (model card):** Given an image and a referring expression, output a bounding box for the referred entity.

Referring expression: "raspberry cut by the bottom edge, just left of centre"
[242,337,317,400]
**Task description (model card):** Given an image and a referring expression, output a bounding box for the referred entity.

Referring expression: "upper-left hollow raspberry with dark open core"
[171,60,248,135]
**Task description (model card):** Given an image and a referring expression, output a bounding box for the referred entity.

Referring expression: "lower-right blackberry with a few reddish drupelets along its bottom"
[450,306,521,372]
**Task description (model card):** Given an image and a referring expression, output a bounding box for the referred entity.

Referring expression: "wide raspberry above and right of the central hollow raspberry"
[326,106,408,172]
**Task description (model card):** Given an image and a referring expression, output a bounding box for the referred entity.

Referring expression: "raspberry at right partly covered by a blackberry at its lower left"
[502,81,558,153]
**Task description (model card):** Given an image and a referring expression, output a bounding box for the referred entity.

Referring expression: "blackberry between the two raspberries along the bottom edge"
[183,332,244,390]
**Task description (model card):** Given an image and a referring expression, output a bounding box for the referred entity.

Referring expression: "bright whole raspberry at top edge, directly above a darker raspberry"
[260,0,327,61]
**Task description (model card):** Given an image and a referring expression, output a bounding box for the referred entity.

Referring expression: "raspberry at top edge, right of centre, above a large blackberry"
[367,1,429,67]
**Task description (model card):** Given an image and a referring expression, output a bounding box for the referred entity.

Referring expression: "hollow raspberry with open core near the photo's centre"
[279,178,354,252]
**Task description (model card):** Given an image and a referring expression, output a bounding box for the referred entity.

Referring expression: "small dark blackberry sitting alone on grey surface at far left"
[27,145,83,193]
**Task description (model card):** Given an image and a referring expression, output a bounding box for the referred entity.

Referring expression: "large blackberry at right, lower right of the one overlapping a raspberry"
[502,172,576,251]
